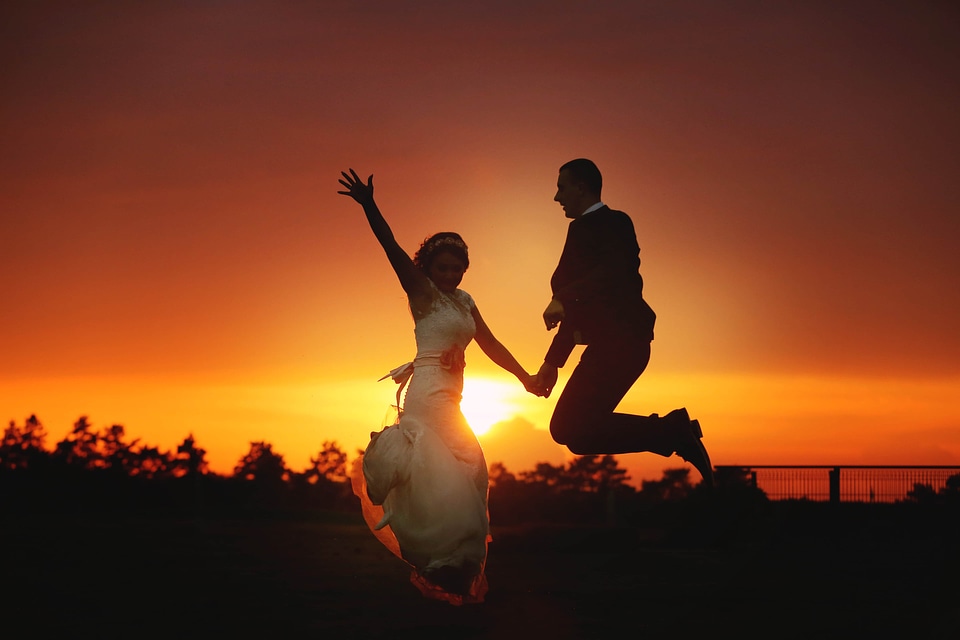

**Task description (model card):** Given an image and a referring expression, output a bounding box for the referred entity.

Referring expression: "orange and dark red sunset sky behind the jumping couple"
[0,0,960,481]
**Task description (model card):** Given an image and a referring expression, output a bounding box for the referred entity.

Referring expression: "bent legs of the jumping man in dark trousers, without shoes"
[550,339,673,456]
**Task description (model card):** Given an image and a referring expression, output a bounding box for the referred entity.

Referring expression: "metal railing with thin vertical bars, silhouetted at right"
[716,465,960,502]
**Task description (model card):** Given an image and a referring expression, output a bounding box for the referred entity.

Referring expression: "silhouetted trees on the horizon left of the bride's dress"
[0,415,356,515]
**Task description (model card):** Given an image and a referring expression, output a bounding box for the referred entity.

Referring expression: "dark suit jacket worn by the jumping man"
[544,206,656,367]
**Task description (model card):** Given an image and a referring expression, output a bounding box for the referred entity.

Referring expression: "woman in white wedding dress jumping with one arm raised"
[337,169,536,604]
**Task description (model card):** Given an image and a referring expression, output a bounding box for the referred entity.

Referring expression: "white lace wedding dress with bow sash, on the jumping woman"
[353,283,489,604]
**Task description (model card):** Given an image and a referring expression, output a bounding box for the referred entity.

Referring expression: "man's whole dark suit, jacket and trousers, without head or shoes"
[544,206,674,455]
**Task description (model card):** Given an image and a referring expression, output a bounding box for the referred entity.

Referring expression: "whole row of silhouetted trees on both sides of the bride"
[0,416,765,524]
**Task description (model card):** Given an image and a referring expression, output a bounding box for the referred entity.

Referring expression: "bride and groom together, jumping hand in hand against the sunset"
[337,158,713,604]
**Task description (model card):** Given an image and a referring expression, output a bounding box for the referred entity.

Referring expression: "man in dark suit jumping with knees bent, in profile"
[537,158,713,486]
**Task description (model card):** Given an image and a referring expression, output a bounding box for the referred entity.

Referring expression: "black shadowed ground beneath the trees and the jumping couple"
[0,503,960,639]
